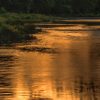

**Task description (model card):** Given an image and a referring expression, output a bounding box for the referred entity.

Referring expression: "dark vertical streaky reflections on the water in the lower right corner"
[74,78,100,100]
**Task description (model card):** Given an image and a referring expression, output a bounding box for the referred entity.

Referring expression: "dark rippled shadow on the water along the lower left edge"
[0,55,15,100]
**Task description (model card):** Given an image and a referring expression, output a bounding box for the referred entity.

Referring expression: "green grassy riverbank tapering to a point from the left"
[0,13,59,44]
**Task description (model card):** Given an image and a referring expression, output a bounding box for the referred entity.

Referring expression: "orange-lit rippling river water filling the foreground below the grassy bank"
[0,25,100,100]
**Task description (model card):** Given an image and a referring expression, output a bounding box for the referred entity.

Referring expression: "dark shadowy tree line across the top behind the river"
[0,0,100,16]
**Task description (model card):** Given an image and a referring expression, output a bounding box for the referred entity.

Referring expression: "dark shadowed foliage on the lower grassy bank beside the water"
[0,23,32,44]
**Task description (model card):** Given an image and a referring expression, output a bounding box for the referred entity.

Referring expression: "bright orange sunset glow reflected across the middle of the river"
[13,26,90,100]
